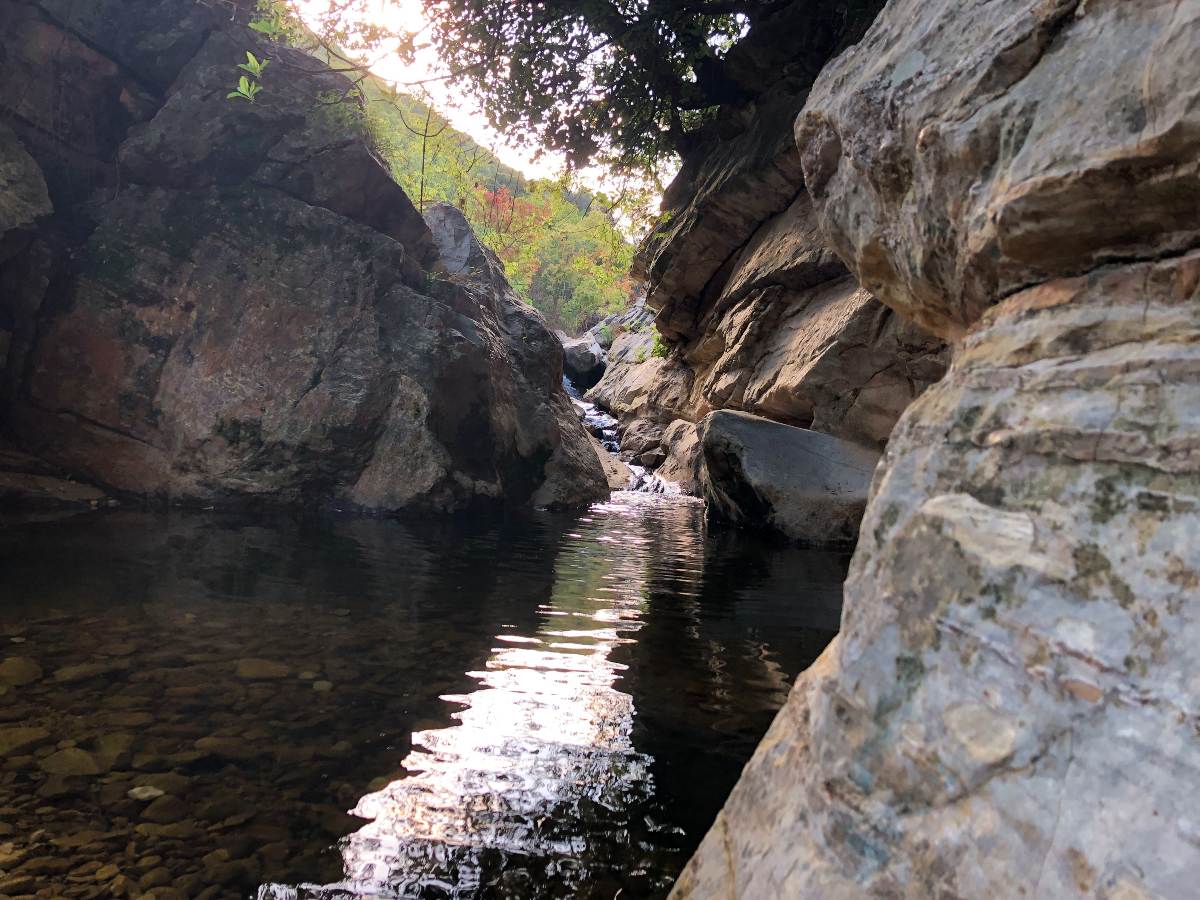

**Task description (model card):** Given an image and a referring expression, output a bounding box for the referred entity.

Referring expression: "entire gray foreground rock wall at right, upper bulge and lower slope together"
[673,0,1200,900]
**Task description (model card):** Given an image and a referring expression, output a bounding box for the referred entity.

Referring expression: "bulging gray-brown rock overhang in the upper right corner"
[797,0,1200,337]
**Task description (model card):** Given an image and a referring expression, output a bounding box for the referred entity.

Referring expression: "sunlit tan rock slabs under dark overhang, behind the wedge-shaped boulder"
[589,193,946,494]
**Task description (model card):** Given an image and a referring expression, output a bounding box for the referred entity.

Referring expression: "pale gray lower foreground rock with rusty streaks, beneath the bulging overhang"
[676,254,1200,898]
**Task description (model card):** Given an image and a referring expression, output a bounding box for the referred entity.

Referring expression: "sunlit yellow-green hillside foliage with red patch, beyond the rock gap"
[238,0,649,332]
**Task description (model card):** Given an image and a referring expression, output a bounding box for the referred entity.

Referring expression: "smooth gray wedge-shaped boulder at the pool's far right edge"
[697,410,880,546]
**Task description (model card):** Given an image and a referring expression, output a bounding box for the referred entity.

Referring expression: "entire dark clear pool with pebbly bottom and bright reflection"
[0,493,846,899]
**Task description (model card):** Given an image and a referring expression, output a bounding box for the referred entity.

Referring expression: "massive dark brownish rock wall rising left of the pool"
[0,0,607,511]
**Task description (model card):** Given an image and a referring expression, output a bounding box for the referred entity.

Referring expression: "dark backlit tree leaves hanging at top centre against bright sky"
[417,0,763,174]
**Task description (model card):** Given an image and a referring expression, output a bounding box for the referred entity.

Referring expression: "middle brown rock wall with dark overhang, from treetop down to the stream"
[588,4,947,512]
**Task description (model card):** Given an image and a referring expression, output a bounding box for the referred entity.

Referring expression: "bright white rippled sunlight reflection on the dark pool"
[264,498,700,898]
